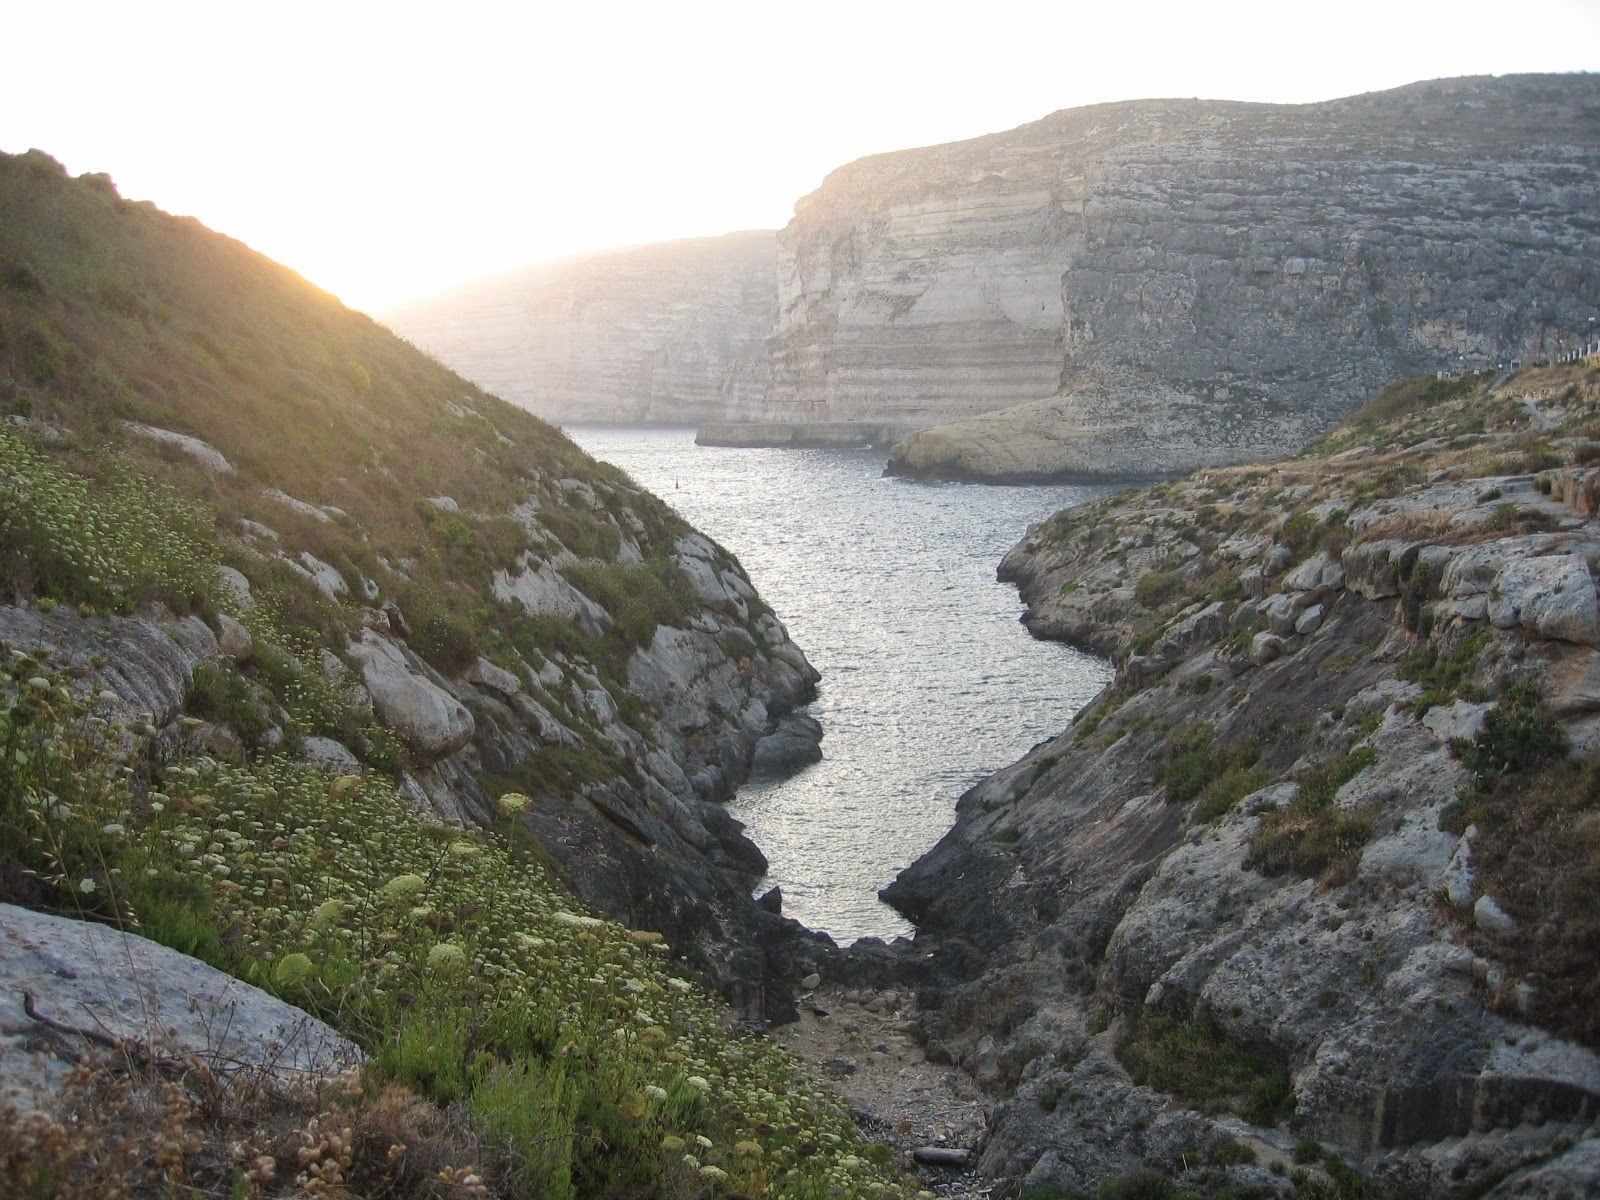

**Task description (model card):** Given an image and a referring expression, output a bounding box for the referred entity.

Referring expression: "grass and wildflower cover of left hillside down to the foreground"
[0,152,899,1197]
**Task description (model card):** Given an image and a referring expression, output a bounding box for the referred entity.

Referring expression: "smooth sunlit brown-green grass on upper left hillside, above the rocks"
[0,152,700,704]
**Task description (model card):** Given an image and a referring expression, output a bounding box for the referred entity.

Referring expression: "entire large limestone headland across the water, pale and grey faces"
[784,75,1600,477]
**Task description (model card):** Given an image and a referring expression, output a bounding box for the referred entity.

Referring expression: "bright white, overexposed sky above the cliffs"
[0,0,1600,314]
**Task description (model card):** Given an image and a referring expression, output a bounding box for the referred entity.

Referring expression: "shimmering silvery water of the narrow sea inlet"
[568,427,1110,942]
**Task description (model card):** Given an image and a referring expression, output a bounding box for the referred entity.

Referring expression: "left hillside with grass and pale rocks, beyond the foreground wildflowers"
[0,152,844,1005]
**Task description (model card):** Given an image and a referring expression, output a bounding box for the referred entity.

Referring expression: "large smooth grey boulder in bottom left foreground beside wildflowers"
[0,904,362,1112]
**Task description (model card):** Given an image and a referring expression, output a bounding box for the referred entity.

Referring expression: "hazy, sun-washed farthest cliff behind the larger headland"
[387,230,778,424]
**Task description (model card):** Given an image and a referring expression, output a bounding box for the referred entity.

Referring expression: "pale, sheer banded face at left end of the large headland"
[762,185,1067,424]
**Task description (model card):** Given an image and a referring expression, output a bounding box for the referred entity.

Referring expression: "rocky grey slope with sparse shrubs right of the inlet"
[885,363,1600,1197]
